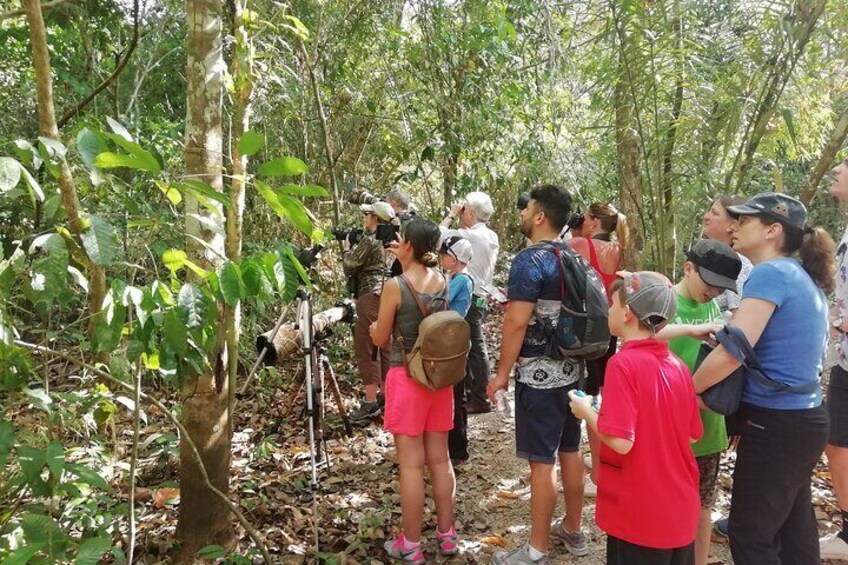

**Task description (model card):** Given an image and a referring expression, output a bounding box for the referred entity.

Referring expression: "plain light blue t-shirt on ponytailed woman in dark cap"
[742,257,827,410]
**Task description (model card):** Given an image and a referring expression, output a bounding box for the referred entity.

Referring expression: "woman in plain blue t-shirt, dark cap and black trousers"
[694,193,835,565]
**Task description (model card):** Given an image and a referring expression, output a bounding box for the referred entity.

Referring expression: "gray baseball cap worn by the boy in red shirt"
[622,271,677,333]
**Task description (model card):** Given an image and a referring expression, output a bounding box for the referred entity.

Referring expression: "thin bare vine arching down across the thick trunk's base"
[14,339,273,564]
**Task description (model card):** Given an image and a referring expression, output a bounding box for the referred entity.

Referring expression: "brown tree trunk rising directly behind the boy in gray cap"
[613,16,645,270]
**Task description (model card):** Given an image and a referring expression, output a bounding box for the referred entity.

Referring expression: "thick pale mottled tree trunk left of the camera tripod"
[176,0,236,563]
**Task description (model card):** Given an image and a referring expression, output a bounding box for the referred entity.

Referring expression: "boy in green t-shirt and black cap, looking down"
[669,239,742,565]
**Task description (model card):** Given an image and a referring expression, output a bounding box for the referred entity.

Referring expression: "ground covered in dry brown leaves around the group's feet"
[121,310,838,565]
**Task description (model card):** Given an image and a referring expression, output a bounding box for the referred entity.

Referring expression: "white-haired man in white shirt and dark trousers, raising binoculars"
[440,192,500,414]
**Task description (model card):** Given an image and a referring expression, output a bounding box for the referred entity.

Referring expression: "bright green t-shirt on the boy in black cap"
[668,294,727,457]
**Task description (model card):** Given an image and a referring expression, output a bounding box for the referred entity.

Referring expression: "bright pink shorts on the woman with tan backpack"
[383,367,453,436]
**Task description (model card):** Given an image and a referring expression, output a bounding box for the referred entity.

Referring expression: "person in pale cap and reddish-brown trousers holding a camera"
[342,201,397,422]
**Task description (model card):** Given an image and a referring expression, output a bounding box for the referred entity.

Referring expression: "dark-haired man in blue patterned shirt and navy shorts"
[488,185,589,565]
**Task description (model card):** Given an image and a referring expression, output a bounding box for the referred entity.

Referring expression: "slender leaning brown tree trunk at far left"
[24,0,106,342]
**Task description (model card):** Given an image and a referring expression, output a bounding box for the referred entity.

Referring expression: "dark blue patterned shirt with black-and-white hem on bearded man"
[507,238,582,388]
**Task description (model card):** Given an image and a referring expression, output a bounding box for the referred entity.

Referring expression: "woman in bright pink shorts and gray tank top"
[370,218,458,564]
